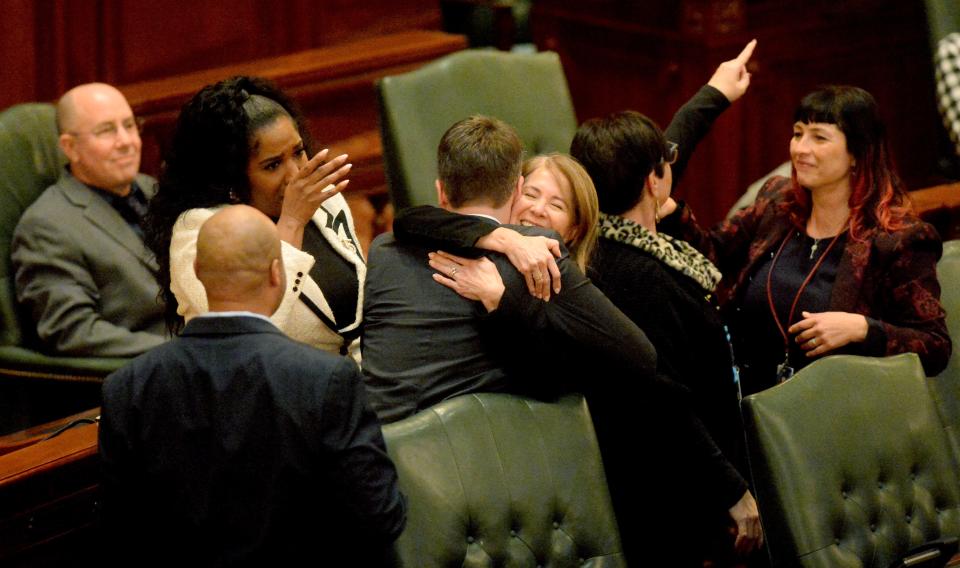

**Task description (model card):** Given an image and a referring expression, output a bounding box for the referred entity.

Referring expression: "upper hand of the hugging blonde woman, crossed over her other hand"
[476,227,560,301]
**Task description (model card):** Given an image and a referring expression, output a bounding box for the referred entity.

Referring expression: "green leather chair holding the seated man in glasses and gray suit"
[0,103,128,384]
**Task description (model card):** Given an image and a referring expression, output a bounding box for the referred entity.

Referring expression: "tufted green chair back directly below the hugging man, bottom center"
[383,393,626,568]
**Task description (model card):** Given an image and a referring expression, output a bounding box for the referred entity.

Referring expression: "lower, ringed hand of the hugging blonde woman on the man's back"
[428,251,506,312]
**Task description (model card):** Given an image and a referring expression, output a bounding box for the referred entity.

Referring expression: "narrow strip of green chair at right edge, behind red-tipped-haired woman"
[928,241,960,461]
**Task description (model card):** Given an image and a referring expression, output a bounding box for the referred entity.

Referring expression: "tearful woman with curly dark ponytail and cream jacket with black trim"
[146,77,366,353]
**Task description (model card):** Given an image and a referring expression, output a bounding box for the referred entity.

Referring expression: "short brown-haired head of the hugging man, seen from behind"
[437,116,523,208]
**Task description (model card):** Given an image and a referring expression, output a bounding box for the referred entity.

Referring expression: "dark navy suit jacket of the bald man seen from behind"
[100,316,405,565]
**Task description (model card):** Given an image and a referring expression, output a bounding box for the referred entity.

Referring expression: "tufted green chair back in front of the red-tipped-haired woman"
[743,353,960,568]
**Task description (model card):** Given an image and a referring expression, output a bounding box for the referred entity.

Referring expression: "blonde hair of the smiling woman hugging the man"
[523,153,600,272]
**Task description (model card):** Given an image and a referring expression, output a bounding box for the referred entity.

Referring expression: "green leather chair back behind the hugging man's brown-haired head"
[377,50,577,211]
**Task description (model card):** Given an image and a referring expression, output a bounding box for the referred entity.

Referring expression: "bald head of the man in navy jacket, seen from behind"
[194,205,286,316]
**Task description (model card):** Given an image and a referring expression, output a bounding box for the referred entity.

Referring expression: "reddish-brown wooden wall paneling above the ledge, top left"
[0,0,440,108]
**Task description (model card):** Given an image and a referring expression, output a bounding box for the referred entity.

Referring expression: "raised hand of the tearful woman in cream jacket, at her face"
[277,150,353,248]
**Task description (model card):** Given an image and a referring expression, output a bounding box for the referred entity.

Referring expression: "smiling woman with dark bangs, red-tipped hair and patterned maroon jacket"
[661,86,951,394]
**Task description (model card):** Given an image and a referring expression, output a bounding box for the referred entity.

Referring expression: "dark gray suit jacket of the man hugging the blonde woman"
[363,217,656,422]
